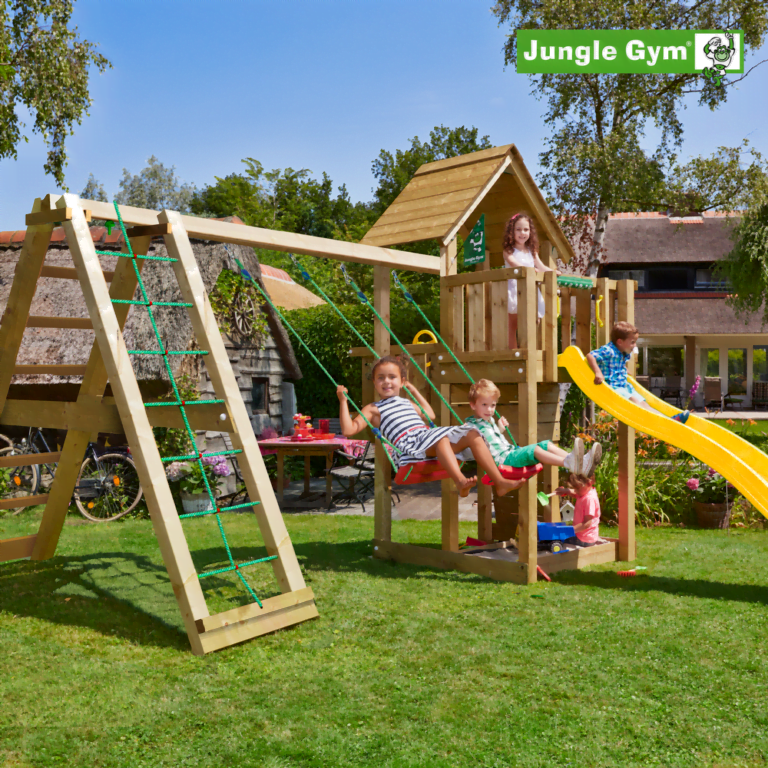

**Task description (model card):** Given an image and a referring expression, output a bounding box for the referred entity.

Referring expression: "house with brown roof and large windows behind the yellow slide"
[600,212,768,407]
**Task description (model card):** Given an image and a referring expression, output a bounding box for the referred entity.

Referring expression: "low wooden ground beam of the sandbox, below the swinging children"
[373,540,536,584]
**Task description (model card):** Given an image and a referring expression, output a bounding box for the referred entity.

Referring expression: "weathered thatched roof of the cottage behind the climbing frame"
[0,227,302,383]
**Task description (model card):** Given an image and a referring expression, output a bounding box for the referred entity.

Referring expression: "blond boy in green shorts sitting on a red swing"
[467,379,602,475]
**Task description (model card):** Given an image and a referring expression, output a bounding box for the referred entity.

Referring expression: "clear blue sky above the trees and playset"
[0,0,768,230]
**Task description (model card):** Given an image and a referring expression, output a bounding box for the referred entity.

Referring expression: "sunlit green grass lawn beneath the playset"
[0,513,768,768]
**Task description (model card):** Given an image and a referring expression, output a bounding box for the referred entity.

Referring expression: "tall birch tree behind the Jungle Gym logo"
[493,0,768,275]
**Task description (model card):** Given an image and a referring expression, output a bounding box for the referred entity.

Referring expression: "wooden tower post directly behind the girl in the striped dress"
[373,265,392,541]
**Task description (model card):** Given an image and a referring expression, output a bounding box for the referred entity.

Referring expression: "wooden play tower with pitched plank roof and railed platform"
[353,145,635,583]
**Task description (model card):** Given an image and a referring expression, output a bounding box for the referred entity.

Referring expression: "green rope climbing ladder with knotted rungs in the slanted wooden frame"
[106,202,277,608]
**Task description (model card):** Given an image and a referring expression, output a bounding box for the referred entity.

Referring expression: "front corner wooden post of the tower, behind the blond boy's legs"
[517,268,538,584]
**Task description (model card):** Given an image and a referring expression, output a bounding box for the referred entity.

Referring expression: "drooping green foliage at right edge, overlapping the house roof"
[715,201,768,324]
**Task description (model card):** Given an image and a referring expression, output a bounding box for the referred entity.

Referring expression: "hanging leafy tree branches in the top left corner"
[0,0,112,188]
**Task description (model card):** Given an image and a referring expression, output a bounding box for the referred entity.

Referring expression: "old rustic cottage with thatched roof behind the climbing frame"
[0,219,322,438]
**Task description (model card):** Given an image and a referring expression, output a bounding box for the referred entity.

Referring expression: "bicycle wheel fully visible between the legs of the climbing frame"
[74,453,144,523]
